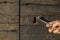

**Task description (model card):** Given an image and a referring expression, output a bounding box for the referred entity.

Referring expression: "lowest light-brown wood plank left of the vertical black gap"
[0,32,19,40]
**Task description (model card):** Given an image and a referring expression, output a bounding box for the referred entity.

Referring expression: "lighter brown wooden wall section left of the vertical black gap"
[0,0,19,40]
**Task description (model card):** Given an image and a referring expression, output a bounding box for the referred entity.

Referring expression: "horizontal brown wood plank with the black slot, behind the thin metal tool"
[20,15,60,26]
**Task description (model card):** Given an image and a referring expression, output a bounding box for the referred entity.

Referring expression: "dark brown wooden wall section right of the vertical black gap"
[20,0,60,40]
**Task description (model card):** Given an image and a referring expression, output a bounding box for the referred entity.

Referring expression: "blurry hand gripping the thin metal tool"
[46,21,60,34]
